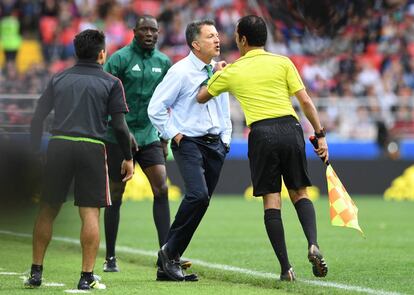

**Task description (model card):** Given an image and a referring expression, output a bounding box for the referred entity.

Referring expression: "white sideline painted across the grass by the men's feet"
[0,230,403,295]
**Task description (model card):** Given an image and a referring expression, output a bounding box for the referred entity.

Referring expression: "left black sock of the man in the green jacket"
[104,201,122,258]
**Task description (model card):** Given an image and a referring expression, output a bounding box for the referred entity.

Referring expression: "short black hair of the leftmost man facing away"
[73,29,105,61]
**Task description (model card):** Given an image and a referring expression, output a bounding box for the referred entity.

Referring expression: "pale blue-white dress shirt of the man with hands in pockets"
[148,52,231,144]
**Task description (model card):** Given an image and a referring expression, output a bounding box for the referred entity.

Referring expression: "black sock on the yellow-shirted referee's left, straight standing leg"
[264,209,291,273]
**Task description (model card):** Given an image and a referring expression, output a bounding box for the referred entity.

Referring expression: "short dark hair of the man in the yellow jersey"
[237,15,267,46]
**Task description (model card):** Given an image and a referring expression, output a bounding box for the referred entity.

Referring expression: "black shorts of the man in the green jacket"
[105,141,165,182]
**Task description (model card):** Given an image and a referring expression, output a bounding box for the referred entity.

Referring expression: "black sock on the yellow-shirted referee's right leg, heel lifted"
[295,198,319,247]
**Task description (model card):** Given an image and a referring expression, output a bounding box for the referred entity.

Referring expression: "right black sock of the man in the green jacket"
[152,193,170,248]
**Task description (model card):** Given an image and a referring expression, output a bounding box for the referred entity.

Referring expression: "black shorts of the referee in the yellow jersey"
[248,116,311,196]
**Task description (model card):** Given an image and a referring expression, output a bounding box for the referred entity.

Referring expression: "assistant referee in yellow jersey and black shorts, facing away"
[197,15,328,281]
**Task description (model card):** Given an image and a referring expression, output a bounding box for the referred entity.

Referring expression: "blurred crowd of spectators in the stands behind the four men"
[0,0,414,146]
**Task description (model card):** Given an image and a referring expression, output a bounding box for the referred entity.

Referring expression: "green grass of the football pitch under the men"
[0,197,414,295]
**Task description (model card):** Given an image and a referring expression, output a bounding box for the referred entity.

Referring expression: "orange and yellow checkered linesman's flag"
[309,136,365,237]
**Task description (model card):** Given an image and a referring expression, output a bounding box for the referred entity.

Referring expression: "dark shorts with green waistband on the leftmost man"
[42,137,111,208]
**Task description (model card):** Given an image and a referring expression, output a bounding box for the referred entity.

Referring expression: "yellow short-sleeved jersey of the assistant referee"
[207,49,305,126]
